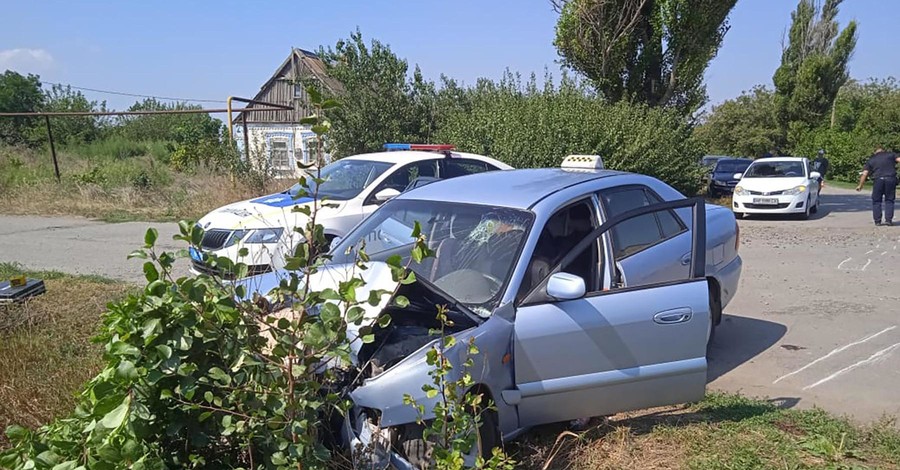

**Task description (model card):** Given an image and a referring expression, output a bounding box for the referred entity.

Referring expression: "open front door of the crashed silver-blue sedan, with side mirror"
[503,199,710,426]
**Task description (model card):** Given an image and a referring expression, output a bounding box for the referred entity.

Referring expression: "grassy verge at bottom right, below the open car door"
[507,393,900,470]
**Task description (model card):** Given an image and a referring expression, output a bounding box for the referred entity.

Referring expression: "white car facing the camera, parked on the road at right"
[732,157,821,219]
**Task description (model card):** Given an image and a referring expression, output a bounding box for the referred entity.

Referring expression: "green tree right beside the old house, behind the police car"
[320,31,434,156]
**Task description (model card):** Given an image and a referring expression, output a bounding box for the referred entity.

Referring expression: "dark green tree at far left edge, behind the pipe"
[0,70,44,145]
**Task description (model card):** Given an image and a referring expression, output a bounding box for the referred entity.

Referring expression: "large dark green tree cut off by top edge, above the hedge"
[554,0,736,113]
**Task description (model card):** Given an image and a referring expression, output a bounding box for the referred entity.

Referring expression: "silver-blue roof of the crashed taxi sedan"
[397,168,628,209]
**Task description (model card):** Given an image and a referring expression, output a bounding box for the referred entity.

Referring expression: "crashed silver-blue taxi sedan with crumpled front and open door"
[239,163,741,468]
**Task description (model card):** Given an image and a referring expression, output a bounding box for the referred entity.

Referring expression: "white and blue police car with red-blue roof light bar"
[190,144,512,276]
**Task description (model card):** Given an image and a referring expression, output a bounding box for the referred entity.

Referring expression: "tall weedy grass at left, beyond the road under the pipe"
[0,143,284,222]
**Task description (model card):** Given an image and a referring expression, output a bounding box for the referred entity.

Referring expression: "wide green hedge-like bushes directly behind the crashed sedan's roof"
[438,74,702,194]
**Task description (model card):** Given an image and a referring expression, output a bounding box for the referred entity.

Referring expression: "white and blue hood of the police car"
[198,193,342,230]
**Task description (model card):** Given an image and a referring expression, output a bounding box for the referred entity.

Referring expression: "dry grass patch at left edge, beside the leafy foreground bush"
[0,263,133,447]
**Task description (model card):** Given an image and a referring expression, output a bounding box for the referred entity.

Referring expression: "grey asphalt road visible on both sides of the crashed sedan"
[0,188,900,421]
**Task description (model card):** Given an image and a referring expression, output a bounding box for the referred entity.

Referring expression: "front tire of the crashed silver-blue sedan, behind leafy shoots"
[399,398,502,469]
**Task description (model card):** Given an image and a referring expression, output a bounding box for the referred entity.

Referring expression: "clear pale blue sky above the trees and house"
[0,0,900,113]
